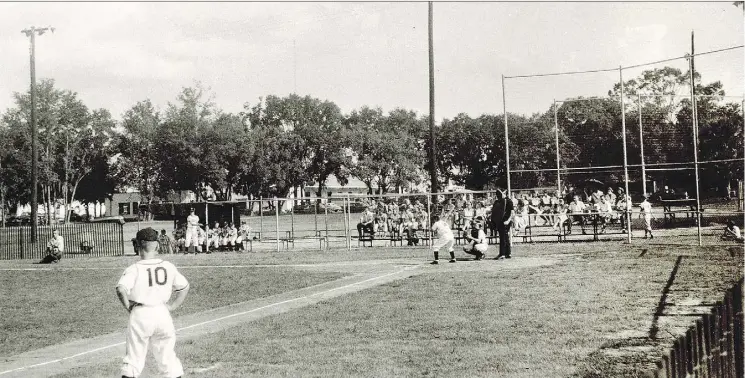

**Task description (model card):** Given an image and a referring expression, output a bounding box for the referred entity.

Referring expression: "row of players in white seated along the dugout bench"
[173,222,256,253]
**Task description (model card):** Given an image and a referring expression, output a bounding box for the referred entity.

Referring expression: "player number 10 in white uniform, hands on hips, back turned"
[116,228,189,378]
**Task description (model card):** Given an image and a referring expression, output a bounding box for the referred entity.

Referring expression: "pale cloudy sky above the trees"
[0,1,745,122]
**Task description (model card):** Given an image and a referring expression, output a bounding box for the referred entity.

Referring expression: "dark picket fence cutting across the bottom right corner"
[654,279,744,378]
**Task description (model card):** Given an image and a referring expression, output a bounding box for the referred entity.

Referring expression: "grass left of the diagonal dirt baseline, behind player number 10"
[0,256,344,357]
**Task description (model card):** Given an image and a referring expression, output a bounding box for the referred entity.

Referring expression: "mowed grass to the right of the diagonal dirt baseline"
[49,243,743,377]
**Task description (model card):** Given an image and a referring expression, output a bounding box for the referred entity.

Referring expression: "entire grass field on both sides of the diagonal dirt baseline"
[0,241,743,377]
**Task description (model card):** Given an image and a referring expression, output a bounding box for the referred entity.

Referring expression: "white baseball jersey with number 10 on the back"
[117,259,189,306]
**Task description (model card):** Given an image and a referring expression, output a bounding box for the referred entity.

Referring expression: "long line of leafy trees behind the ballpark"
[0,67,743,219]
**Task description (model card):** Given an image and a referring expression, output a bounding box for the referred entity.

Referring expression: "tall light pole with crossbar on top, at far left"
[21,26,54,243]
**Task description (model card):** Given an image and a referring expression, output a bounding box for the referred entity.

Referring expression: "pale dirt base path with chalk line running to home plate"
[0,257,558,378]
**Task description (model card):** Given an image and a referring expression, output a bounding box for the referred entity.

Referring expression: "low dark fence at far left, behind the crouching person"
[0,223,124,260]
